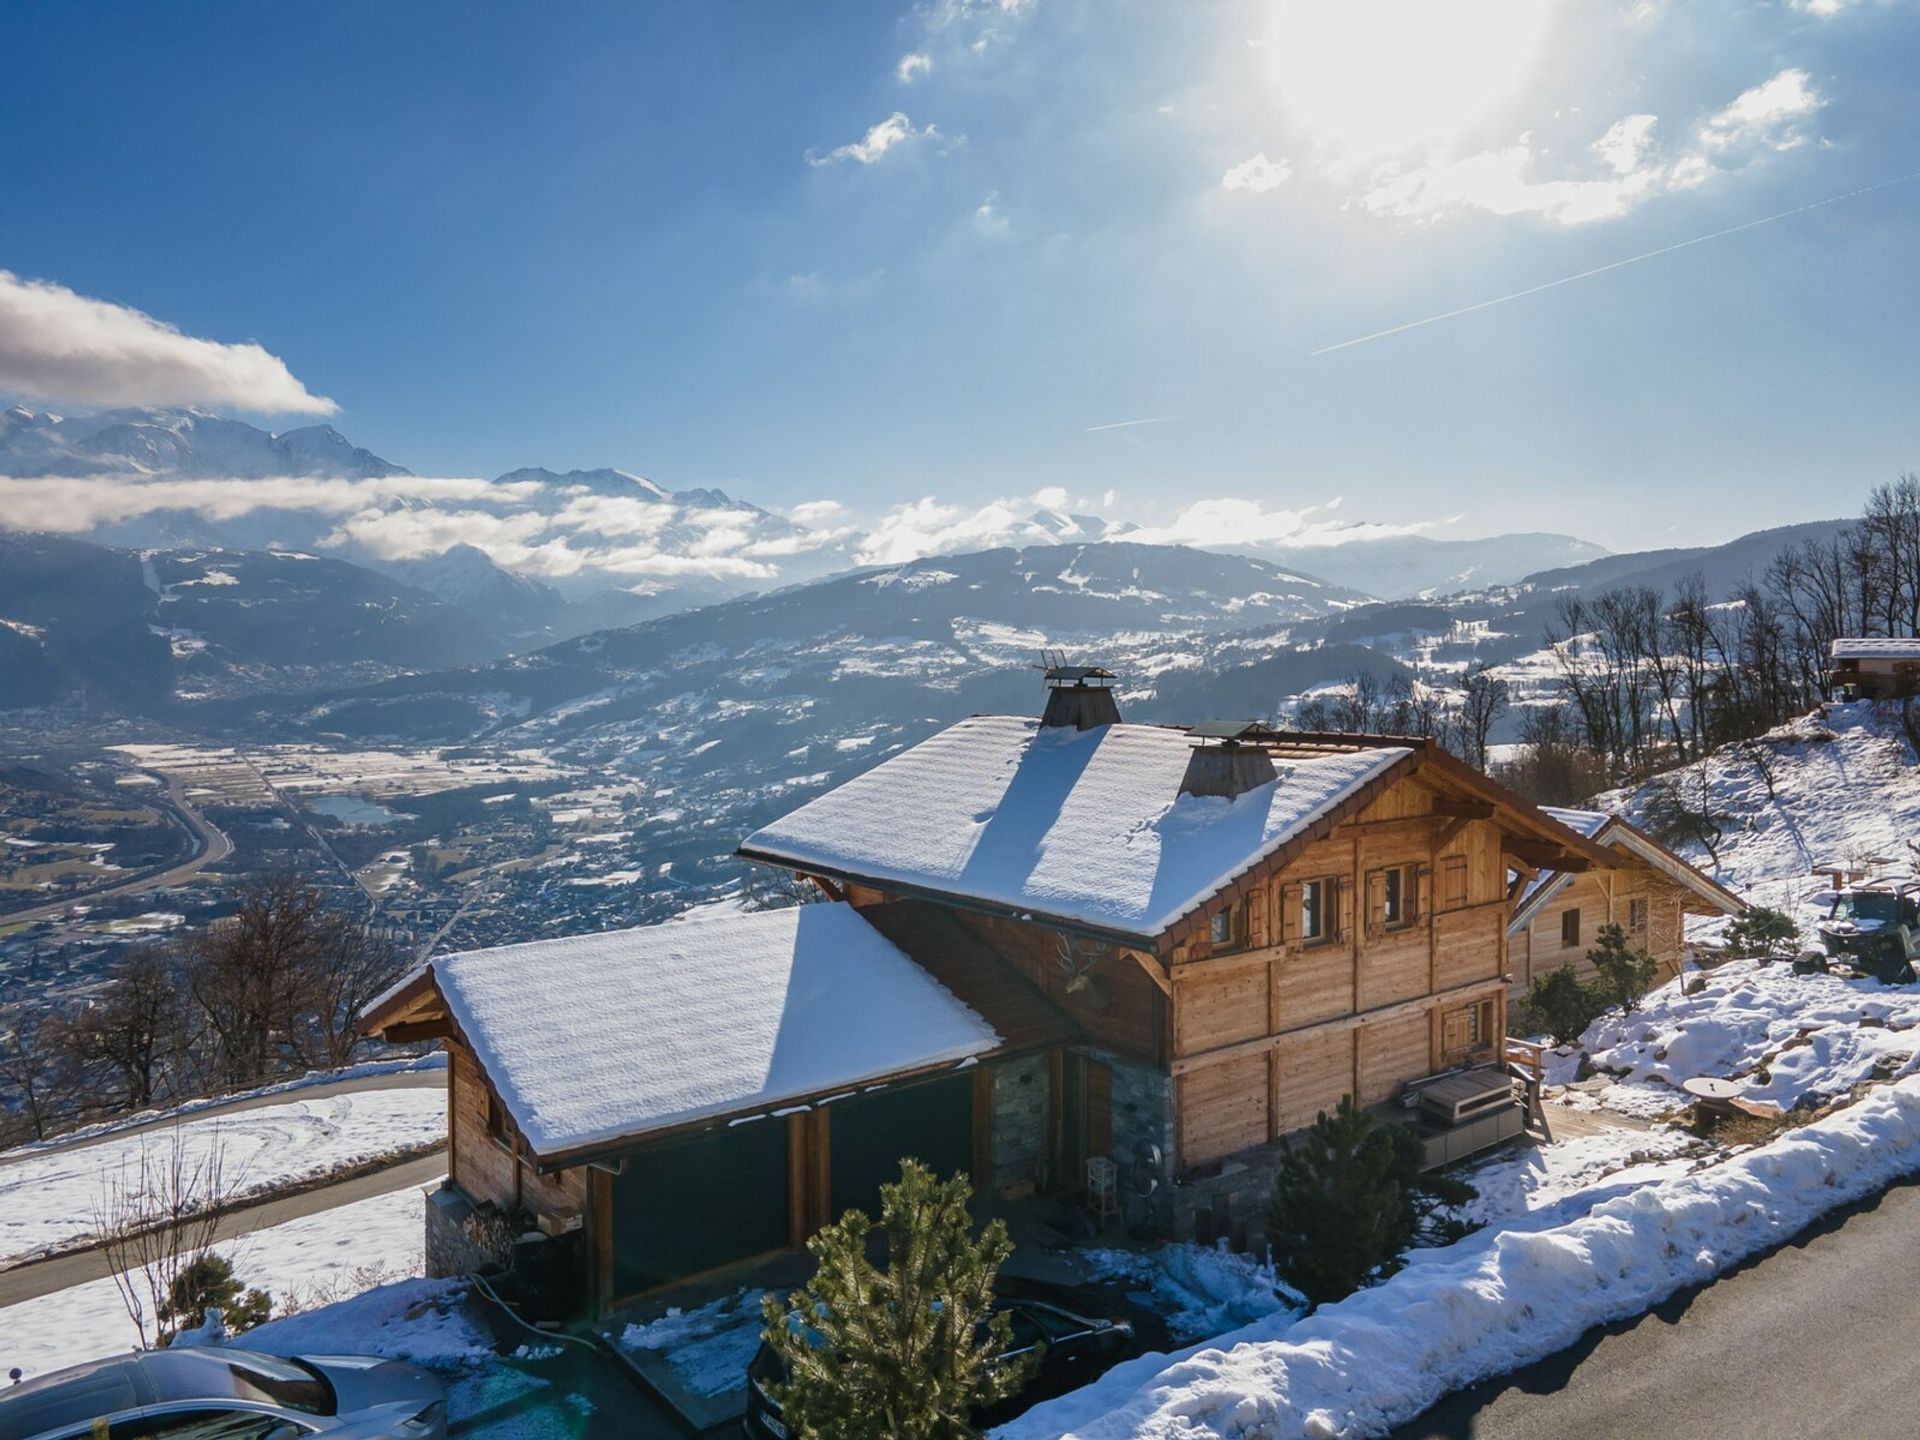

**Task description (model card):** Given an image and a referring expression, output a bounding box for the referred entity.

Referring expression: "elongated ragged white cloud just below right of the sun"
[1357,69,1826,225]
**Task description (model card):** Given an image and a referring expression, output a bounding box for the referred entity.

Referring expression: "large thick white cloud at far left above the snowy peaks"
[0,271,340,415]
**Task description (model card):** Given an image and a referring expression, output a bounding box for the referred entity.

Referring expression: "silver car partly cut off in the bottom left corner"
[0,1350,447,1440]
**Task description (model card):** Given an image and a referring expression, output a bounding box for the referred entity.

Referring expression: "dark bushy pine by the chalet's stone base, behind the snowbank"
[1267,1094,1475,1308]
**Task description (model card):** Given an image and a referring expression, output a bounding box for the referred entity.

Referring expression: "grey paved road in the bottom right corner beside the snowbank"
[1392,1183,1920,1440]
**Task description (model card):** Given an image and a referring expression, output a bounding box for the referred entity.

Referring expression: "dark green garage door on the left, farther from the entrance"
[612,1119,789,1298]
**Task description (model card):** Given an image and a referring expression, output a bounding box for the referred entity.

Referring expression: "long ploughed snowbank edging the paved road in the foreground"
[995,1077,1920,1440]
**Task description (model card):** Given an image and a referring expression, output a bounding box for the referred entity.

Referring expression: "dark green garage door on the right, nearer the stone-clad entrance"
[828,1075,973,1219]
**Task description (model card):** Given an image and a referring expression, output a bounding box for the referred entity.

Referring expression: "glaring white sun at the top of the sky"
[1265,0,1557,161]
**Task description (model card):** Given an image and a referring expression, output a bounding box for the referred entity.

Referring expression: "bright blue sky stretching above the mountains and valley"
[0,0,1920,549]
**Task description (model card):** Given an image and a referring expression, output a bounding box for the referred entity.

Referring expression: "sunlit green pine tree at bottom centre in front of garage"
[764,1160,1039,1440]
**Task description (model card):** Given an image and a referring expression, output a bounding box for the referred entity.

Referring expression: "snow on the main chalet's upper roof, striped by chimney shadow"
[741,716,1411,937]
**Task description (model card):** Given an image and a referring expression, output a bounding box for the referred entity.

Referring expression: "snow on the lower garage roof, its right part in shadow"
[432,904,1000,1156]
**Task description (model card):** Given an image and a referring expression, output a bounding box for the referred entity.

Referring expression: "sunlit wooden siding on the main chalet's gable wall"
[1167,778,1511,1165]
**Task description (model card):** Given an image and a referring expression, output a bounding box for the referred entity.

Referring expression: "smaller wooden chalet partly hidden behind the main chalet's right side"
[1507,808,1747,991]
